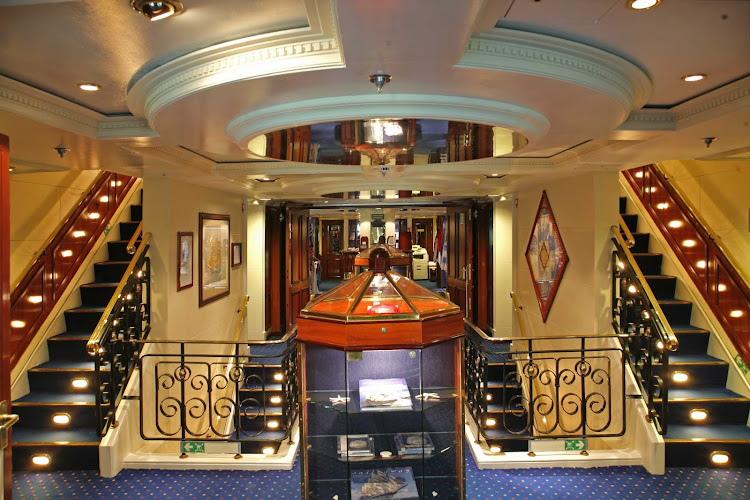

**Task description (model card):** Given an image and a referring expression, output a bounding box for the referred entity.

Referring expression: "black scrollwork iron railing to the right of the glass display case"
[464,321,626,440]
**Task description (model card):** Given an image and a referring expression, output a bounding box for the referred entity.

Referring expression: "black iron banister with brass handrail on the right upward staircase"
[612,220,679,434]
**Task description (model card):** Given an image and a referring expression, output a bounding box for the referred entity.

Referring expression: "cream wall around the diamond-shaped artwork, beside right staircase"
[513,172,619,336]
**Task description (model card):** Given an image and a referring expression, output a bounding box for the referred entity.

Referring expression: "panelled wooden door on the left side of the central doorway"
[285,209,311,331]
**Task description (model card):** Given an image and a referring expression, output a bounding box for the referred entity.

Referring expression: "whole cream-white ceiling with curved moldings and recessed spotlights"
[0,0,750,199]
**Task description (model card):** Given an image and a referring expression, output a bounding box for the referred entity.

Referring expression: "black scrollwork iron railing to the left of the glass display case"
[139,328,299,443]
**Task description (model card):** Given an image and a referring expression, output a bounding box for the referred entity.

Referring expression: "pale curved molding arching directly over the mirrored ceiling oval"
[227,93,550,149]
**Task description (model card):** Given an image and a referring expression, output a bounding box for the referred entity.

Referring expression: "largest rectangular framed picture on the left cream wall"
[198,212,229,307]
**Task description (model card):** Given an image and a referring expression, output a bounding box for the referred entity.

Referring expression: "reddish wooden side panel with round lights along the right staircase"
[622,165,750,363]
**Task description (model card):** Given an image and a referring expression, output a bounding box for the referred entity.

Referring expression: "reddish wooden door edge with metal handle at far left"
[0,134,13,498]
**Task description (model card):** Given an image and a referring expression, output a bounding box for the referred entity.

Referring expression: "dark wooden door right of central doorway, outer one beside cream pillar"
[472,203,494,332]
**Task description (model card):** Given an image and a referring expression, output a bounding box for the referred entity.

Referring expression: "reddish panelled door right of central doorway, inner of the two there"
[445,205,473,319]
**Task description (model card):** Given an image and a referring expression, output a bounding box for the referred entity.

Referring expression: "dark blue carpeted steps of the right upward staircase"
[620,197,750,467]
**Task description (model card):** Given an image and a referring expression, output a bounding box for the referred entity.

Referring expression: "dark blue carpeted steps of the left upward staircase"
[12,198,142,471]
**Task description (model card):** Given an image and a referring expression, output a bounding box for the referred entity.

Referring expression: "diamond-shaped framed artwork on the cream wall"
[526,191,568,323]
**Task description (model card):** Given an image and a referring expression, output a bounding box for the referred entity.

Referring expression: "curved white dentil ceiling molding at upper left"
[127,0,346,122]
